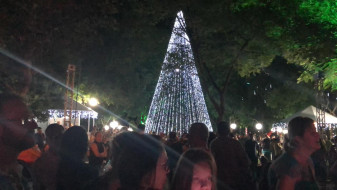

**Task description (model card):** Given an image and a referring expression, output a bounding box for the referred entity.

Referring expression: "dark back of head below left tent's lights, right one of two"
[60,126,88,161]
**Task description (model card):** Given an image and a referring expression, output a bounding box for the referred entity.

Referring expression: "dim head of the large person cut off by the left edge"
[0,94,37,152]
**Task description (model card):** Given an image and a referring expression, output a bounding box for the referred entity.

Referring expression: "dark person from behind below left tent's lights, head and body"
[57,126,98,190]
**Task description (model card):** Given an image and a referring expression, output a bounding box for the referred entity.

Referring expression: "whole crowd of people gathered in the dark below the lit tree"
[0,94,337,190]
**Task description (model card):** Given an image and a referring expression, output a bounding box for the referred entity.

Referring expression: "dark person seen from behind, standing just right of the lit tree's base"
[211,121,255,190]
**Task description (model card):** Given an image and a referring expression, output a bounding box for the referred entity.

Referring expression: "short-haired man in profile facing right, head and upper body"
[268,117,320,190]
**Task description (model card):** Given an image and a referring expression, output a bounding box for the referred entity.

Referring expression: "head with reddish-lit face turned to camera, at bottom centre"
[171,149,216,190]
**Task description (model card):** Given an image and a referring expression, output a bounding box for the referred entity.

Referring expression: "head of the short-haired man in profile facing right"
[285,117,320,154]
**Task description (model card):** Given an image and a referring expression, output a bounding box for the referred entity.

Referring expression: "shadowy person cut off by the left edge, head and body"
[0,94,37,189]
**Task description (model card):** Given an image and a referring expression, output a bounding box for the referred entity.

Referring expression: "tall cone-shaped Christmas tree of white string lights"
[145,11,213,134]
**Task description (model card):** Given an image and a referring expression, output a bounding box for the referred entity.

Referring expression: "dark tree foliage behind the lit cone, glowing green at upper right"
[0,0,337,126]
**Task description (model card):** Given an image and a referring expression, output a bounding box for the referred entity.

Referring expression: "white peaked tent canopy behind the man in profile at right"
[281,105,337,124]
